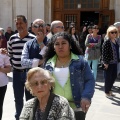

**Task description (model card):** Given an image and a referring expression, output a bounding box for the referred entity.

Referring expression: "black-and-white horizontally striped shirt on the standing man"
[8,33,35,69]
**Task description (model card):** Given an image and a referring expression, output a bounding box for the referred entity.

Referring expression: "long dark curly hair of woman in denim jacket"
[44,32,82,61]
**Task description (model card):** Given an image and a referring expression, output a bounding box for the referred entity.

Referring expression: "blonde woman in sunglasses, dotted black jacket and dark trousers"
[102,25,119,98]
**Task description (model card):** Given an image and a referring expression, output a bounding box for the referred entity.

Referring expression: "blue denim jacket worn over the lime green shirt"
[45,53,95,108]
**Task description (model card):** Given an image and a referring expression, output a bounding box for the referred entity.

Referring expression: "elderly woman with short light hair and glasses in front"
[20,67,75,120]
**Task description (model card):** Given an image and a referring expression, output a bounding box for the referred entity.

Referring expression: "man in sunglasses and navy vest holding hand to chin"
[21,19,48,69]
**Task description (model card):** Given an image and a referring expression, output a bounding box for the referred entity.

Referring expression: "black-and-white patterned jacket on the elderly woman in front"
[19,95,75,120]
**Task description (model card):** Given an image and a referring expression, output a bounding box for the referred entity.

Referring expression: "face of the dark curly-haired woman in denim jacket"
[54,37,70,57]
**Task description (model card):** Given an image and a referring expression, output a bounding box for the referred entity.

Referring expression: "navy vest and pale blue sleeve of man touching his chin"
[21,37,47,68]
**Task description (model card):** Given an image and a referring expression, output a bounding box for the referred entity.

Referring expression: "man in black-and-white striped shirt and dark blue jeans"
[8,15,35,120]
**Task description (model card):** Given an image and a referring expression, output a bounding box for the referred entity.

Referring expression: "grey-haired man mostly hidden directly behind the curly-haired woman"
[47,20,64,39]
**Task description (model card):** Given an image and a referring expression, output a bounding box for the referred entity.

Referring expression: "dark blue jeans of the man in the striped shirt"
[13,70,33,120]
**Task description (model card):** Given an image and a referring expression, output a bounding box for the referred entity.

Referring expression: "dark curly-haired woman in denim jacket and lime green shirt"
[45,32,95,120]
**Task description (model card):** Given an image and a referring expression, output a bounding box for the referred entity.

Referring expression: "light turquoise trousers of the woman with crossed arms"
[87,59,99,80]
